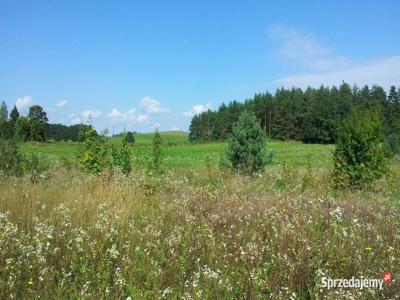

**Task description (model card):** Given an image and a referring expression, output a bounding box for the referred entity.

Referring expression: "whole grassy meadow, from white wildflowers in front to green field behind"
[0,132,400,299]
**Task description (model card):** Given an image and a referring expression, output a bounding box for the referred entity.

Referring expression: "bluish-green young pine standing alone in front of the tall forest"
[227,112,267,174]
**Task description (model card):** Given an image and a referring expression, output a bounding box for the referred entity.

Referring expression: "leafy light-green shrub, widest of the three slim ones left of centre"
[79,128,108,175]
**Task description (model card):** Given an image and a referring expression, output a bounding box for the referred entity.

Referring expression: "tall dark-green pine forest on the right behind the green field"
[189,82,400,143]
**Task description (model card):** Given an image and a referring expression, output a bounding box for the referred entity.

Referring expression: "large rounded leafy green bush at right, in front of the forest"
[333,111,388,188]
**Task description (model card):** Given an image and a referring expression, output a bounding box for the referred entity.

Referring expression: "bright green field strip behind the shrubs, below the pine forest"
[22,131,334,169]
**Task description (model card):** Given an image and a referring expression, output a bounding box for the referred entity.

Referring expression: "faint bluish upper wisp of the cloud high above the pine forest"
[268,26,354,70]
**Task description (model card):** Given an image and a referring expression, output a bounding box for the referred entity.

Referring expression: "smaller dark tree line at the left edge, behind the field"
[0,101,91,142]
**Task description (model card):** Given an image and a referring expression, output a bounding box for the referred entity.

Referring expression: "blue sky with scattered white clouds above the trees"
[0,0,400,133]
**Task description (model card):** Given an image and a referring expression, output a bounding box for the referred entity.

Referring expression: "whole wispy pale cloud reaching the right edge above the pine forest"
[268,26,400,88]
